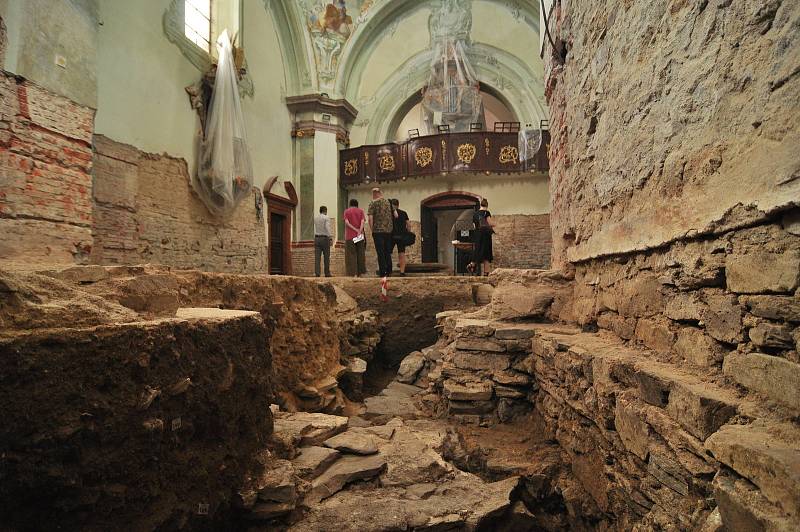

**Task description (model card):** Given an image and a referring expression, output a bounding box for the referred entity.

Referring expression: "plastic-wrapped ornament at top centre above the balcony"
[422,0,485,135]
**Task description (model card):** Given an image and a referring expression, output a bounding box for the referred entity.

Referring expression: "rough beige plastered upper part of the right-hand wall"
[546,0,800,266]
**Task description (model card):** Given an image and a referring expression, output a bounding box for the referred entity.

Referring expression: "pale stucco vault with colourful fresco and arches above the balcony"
[264,0,547,143]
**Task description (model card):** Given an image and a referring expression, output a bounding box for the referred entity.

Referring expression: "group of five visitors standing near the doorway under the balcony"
[314,187,495,277]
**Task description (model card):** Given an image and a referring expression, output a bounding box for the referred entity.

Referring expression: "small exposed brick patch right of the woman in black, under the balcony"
[492,214,553,269]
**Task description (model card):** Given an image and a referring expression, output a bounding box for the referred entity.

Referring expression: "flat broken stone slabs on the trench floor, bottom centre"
[239,407,533,531]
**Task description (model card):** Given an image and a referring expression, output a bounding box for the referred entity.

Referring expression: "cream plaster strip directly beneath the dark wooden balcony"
[348,176,550,220]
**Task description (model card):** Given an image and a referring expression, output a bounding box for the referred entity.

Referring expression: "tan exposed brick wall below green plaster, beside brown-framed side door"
[92,135,266,273]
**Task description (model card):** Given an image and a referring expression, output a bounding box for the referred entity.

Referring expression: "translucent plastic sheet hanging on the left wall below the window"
[192,31,253,216]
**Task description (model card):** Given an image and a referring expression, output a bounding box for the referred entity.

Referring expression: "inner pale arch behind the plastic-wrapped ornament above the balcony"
[366,43,548,144]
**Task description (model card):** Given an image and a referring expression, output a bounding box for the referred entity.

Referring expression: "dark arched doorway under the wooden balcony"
[420,191,480,267]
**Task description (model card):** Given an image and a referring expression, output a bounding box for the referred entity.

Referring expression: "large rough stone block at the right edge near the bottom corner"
[705,424,800,516]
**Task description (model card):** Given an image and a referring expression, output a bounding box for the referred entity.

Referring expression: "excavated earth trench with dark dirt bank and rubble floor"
[0,267,582,532]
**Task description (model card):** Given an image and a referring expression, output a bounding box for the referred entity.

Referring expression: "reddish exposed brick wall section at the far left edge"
[0,72,94,265]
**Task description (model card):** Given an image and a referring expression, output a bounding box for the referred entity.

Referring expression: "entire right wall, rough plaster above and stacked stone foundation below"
[534,0,800,530]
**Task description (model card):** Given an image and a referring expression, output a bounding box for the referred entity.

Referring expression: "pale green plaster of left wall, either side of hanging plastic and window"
[96,0,292,190]
